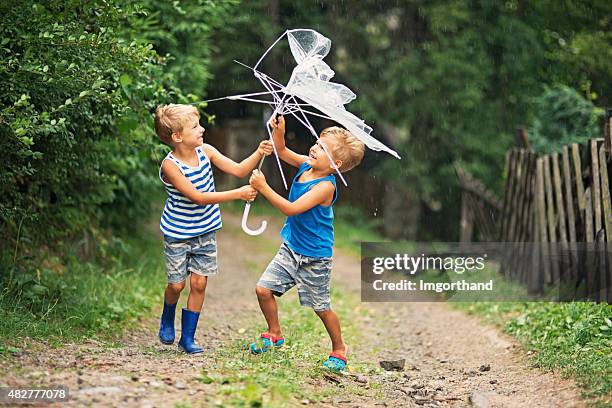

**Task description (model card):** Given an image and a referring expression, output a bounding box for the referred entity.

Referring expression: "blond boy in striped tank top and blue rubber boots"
[155,104,272,354]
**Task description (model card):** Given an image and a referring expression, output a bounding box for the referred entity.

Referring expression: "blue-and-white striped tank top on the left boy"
[159,146,221,239]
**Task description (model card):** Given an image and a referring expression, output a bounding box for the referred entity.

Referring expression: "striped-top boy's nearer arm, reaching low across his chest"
[162,160,257,205]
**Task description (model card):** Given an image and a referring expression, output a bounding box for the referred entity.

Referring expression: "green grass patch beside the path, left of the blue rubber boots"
[0,225,165,354]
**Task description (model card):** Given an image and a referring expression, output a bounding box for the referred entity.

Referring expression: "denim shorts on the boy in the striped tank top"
[164,231,217,283]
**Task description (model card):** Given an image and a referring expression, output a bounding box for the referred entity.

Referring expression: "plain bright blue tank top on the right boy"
[281,163,338,258]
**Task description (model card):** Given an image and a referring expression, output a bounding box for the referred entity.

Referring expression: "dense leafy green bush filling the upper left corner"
[0,1,168,249]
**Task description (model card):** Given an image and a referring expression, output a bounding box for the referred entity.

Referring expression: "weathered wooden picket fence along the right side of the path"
[457,115,612,302]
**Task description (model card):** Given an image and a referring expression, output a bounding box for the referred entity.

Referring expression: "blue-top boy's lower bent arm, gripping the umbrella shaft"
[249,170,335,216]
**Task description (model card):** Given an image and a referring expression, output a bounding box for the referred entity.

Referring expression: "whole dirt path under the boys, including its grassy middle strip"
[0,213,584,407]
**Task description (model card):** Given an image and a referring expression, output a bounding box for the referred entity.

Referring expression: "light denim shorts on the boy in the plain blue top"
[257,242,332,312]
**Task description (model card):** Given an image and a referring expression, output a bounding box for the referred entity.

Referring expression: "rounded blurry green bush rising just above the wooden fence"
[529,85,604,153]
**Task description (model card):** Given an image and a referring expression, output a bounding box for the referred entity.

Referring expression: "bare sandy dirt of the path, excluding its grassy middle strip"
[0,214,584,408]
